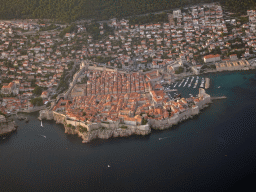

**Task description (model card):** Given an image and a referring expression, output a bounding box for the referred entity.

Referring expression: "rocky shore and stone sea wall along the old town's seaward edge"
[38,90,212,143]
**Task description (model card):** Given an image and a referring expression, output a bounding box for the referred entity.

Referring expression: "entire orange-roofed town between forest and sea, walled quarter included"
[0,3,256,142]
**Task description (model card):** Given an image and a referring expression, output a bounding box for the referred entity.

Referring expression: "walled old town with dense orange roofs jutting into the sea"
[39,61,211,143]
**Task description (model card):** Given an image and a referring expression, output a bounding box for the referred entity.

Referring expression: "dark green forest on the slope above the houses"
[0,0,256,23]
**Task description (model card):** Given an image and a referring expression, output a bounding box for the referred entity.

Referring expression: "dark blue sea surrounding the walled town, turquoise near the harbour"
[0,70,256,192]
